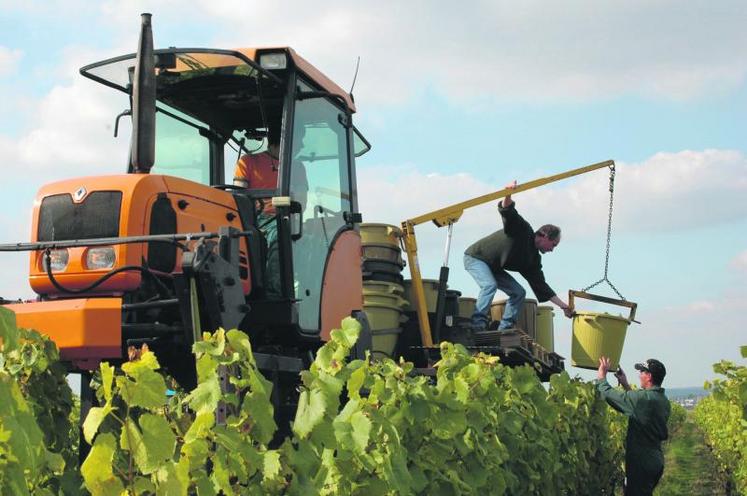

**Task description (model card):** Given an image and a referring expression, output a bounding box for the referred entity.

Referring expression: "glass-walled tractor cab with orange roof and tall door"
[81,48,370,335]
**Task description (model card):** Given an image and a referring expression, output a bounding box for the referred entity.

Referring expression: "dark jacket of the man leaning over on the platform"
[464,203,555,303]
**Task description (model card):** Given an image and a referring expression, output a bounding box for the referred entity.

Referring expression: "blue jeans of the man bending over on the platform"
[464,255,527,329]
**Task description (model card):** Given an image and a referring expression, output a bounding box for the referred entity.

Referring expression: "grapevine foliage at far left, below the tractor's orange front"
[0,307,82,494]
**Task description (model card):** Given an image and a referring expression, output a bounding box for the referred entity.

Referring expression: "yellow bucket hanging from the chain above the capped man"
[571,312,630,370]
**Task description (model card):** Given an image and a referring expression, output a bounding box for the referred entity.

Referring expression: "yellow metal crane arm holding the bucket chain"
[402,160,615,347]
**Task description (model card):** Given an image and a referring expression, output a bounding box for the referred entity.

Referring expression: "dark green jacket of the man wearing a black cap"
[597,379,672,454]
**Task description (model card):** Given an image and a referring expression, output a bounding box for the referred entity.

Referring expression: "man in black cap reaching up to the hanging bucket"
[597,357,671,496]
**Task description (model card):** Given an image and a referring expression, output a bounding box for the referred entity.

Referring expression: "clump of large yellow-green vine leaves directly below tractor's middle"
[81,329,280,496]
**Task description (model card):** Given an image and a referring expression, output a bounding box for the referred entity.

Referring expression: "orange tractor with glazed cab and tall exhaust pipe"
[0,14,370,404]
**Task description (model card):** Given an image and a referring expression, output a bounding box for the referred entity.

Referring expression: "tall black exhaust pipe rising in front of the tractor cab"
[130,14,156,174]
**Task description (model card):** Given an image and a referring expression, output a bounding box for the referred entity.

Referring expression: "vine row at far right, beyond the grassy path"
[695,346,747,494]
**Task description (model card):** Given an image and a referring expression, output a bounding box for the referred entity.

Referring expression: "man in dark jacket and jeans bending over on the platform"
[464,181,573,330]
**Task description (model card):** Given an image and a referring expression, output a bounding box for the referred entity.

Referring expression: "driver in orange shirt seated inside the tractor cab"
[233,126,306,298]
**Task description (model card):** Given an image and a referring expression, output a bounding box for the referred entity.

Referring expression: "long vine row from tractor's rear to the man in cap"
[281,322,624,495]
